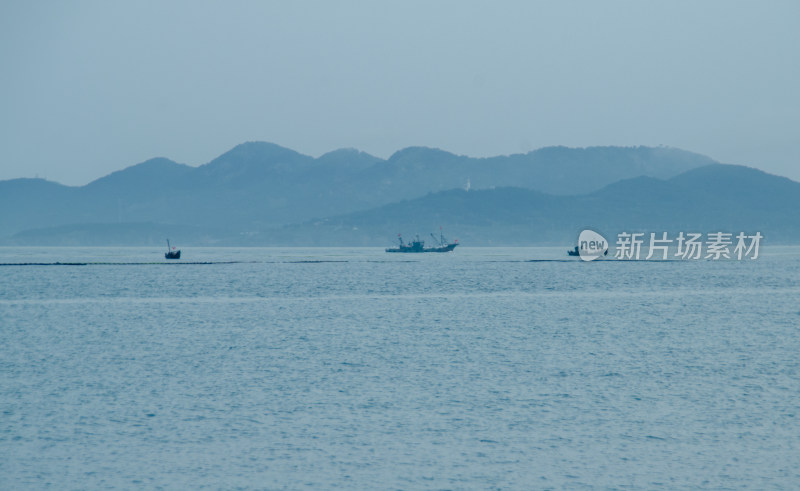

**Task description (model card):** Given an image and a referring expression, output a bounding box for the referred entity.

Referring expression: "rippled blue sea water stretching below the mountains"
[0,247,800,489]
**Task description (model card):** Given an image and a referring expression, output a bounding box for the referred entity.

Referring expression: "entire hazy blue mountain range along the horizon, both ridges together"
[0,142,800,246]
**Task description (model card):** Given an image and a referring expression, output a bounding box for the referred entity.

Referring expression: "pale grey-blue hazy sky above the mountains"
[0,0,800,185]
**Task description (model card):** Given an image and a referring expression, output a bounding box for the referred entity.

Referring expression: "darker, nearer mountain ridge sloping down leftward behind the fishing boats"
[270,164,800,245]
